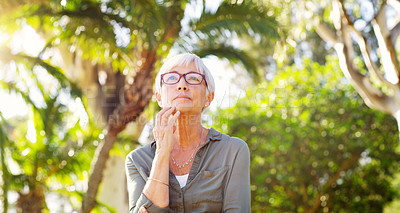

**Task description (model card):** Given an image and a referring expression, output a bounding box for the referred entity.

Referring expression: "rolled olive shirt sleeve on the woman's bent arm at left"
[125,153,169,213]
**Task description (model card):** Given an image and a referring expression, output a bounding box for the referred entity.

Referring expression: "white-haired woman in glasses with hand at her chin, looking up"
[126,53,250,213]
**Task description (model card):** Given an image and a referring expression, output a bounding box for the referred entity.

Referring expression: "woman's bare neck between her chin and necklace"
[174,113,203,151]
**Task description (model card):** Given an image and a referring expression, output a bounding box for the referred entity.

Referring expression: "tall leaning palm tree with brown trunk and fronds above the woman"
[1,0,278,212]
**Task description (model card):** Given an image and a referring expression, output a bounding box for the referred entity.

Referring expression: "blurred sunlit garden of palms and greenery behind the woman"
[0,0,400,213]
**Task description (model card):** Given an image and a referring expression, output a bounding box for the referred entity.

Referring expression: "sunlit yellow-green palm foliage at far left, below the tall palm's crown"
[0,55,101,211]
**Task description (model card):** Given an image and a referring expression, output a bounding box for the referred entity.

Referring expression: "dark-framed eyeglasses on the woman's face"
[161,71,207,86]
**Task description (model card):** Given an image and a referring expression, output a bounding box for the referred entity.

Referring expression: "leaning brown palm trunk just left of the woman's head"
[82,51,156,213]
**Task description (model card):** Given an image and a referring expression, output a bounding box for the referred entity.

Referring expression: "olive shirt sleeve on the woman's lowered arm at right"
[223,141,251,212]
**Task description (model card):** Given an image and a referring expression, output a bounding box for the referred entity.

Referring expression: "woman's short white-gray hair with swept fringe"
[154,53,215,95]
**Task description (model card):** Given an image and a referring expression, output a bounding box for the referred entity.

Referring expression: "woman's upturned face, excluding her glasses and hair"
[156,62,214,113]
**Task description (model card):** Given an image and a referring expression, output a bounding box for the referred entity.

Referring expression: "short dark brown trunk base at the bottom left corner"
[17,186,46,213]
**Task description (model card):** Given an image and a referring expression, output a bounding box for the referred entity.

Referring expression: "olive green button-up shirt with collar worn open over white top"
[125,128,250,213]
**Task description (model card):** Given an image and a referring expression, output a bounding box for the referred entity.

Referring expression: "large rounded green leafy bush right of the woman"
[214,59,400,212]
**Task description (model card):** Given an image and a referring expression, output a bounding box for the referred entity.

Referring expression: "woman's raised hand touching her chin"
[153,107,180,153]
